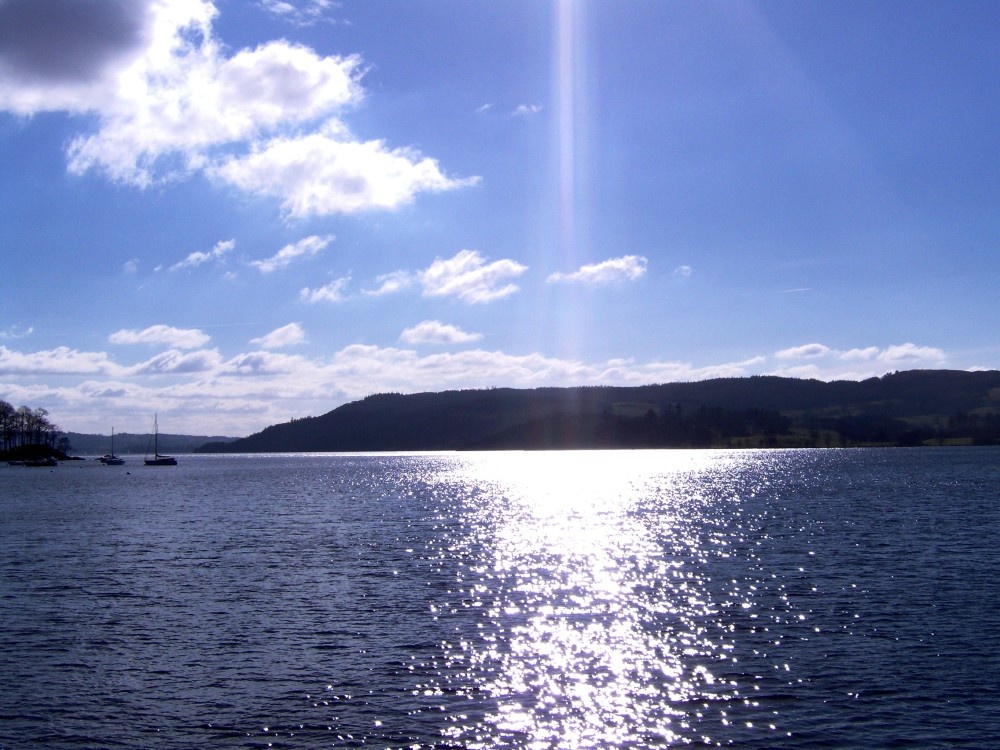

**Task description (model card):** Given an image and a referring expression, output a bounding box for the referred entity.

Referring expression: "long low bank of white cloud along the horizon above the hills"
[0,340,968,435]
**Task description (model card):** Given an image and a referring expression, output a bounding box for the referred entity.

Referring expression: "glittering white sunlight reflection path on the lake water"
[428,452,756,748]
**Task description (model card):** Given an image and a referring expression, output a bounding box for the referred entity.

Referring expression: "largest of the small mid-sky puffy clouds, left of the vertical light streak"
[417,250,528,303]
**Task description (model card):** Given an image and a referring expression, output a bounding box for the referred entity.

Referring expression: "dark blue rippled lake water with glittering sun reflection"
[0,448,1000,750]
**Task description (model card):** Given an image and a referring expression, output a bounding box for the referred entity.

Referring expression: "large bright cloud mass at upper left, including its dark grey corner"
[0,0,476,217]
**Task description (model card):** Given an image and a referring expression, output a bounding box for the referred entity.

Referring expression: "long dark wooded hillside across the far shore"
[199,370,1000,452]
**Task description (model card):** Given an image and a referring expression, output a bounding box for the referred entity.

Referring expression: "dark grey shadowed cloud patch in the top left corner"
[0,0,149,83]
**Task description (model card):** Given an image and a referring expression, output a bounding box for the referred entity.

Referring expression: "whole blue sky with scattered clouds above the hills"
[0,0,1000,435]
